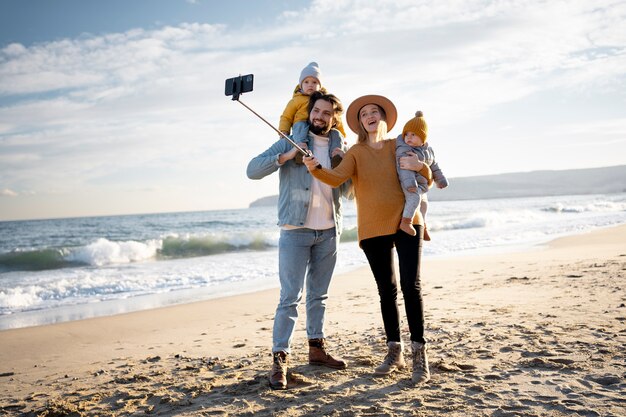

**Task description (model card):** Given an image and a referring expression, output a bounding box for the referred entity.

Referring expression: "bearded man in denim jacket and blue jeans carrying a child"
[247,92,350,389]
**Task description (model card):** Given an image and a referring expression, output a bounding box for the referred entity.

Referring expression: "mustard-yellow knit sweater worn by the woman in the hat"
[311,139,424,242]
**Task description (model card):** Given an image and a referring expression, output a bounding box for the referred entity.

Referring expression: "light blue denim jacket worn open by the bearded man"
[246,129,352,235]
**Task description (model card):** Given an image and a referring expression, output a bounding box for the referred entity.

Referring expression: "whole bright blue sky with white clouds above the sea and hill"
[0,0,626,221]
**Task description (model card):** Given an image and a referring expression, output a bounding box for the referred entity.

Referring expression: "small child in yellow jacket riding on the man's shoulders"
[278,62,346,167]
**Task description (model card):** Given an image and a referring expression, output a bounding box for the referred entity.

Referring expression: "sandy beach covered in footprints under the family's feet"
[0,225,626,416]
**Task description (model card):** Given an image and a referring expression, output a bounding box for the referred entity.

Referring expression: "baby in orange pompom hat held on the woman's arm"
[396,110,448,240]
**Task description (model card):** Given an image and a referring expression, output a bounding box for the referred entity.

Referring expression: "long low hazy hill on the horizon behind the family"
[250,165,626,207]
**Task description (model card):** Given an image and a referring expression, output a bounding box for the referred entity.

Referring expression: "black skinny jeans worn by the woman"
[361,225,426,343]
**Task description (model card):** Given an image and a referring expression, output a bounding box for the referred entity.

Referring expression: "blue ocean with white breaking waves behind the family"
[0,194,626,330]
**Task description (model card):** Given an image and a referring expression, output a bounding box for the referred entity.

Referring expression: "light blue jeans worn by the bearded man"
[272,227,338,353]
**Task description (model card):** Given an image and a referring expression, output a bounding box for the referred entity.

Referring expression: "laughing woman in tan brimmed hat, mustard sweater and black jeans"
[304,95,430,384]
